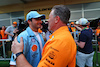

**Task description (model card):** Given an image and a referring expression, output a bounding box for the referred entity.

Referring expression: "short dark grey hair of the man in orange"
[52,5,70,24]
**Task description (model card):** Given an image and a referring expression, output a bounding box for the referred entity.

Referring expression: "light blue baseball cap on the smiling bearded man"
[26,11,45,21]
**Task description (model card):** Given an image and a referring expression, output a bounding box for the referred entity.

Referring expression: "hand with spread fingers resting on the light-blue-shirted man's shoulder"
[11,37,24,54]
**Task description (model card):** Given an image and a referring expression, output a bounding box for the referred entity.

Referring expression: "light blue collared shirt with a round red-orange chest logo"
[10,27,44,67]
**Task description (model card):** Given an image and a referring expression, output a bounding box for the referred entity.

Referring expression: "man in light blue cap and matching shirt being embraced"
[10,11,45,67]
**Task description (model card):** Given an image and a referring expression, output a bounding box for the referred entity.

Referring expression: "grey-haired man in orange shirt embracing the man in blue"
[12,5,76,67]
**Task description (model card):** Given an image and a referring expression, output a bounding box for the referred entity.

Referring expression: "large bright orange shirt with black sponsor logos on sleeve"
[38,26,76,67]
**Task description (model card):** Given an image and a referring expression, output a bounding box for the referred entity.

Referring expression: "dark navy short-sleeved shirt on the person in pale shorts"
[78,28,93,54]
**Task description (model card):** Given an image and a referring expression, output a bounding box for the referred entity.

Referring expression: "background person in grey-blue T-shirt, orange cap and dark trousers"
[5,21,18,57]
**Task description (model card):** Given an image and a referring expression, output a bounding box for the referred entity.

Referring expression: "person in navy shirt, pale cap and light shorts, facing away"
[75,18,94,67]
